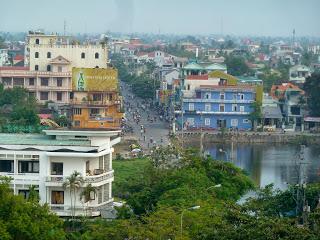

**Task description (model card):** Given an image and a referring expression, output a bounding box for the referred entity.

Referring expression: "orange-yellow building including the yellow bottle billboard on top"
[71,68,123,129]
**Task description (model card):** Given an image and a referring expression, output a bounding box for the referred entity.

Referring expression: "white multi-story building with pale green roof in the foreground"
[0,130,120,216]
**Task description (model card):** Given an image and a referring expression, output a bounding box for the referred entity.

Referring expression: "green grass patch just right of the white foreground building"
[112,158,150,198]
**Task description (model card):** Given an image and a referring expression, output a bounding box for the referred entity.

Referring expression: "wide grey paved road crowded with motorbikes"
[121,82,169,150]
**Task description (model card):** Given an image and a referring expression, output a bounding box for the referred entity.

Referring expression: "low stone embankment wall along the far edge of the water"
[176,132,320,144]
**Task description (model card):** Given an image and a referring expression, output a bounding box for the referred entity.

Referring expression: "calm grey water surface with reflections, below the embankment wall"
[204,143,320,189]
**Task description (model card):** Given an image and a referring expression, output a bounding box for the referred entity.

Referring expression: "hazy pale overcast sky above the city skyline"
[0,0,320,37]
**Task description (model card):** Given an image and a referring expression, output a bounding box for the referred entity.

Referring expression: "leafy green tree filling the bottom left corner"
[0,177,65,240]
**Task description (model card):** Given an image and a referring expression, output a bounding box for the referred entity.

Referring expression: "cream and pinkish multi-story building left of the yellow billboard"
[0,33,108,104]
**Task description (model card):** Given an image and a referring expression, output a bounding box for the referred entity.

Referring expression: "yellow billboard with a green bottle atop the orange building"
[72,68,118,91]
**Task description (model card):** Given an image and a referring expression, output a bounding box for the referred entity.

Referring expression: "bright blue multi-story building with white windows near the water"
[177,85,256,130]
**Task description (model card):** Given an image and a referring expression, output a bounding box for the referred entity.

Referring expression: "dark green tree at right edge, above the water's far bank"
[303,73,320,117]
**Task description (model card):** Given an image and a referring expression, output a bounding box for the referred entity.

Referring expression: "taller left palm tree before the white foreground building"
[62,171,84,219]
